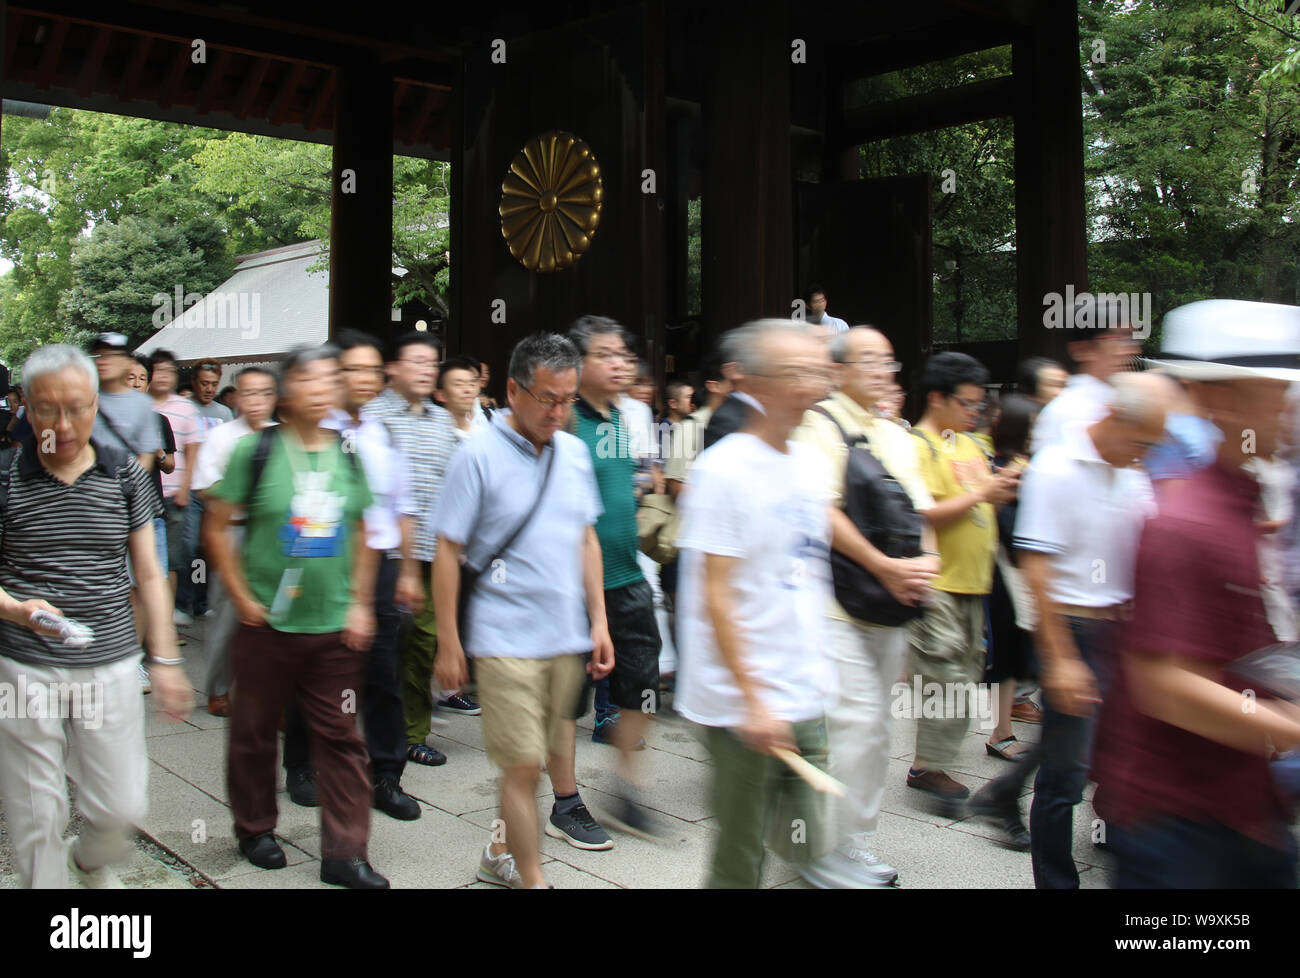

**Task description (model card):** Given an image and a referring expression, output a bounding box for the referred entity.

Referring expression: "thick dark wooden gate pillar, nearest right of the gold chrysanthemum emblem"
[701,0,794,347]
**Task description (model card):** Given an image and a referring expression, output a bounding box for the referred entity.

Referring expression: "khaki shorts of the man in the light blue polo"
[475,654,586,767]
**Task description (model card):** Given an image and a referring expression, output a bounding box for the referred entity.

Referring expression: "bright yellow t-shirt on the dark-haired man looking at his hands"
[911,428,997,594]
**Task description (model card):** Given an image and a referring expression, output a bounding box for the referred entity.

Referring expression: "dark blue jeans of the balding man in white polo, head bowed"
[1030,618,1118,890]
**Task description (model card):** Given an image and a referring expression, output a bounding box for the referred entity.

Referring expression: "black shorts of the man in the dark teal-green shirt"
[573,580,663,718]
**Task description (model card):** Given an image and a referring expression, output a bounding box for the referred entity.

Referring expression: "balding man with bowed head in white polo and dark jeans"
[970,373,1165,890]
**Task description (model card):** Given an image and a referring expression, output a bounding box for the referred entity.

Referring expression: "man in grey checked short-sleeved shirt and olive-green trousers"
[361,332,465,767]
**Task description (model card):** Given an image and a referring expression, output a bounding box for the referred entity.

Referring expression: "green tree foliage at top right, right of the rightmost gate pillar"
[1079,0,1300,342]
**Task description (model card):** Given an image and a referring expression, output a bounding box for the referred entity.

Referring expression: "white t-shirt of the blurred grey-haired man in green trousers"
[675,432,832,727]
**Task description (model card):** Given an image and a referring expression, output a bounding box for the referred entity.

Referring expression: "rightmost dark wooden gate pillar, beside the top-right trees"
[1011,0,1088,360]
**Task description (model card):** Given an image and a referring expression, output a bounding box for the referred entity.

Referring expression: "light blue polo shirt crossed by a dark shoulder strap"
[434,411,602,659]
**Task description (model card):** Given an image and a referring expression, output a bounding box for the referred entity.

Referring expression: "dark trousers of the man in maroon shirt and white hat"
[1110,817,1296,890]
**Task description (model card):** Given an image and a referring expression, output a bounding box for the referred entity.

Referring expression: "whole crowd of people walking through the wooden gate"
[0,286,1300,888]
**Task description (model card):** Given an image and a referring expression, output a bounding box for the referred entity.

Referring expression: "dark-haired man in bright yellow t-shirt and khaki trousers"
[907,352,1019,815]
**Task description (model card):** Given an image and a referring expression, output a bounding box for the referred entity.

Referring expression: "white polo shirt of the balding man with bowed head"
[1015,421,1156,607]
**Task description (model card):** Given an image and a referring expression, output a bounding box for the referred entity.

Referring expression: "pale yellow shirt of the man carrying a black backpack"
[790,390,935,628]
